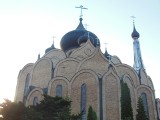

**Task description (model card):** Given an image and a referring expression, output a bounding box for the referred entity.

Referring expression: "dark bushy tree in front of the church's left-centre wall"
[35,95,71,120]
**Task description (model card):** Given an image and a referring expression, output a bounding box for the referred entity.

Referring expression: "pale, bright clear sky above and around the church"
[0,0,160,102]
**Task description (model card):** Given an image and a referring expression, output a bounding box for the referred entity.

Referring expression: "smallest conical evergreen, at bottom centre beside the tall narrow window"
[87,106,97,120]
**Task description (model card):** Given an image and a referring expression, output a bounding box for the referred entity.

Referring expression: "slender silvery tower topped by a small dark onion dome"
[131,21,144,74]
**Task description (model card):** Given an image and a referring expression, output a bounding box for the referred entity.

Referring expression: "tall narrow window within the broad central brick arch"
[81,83,87,120]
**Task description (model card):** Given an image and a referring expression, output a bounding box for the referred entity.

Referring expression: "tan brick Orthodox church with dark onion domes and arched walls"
[15,7,160,120]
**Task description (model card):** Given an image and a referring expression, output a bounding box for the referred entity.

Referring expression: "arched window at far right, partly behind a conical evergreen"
[141,93,149,118]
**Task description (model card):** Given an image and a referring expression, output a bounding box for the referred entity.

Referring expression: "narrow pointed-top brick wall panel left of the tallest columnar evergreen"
[102,69,121,120]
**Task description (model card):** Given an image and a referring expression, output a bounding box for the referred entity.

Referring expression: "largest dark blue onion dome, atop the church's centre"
[60,18,100,52]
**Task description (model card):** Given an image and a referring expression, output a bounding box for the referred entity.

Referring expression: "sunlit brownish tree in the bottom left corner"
[0,99,43,120]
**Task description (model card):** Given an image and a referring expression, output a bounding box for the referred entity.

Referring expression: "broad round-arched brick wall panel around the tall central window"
[70,70,100,118]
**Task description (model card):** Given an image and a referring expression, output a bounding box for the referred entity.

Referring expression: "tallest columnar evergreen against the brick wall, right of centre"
[121,81,133,120]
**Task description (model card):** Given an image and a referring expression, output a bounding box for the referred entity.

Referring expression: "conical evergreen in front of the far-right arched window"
[136,97,148,120]
